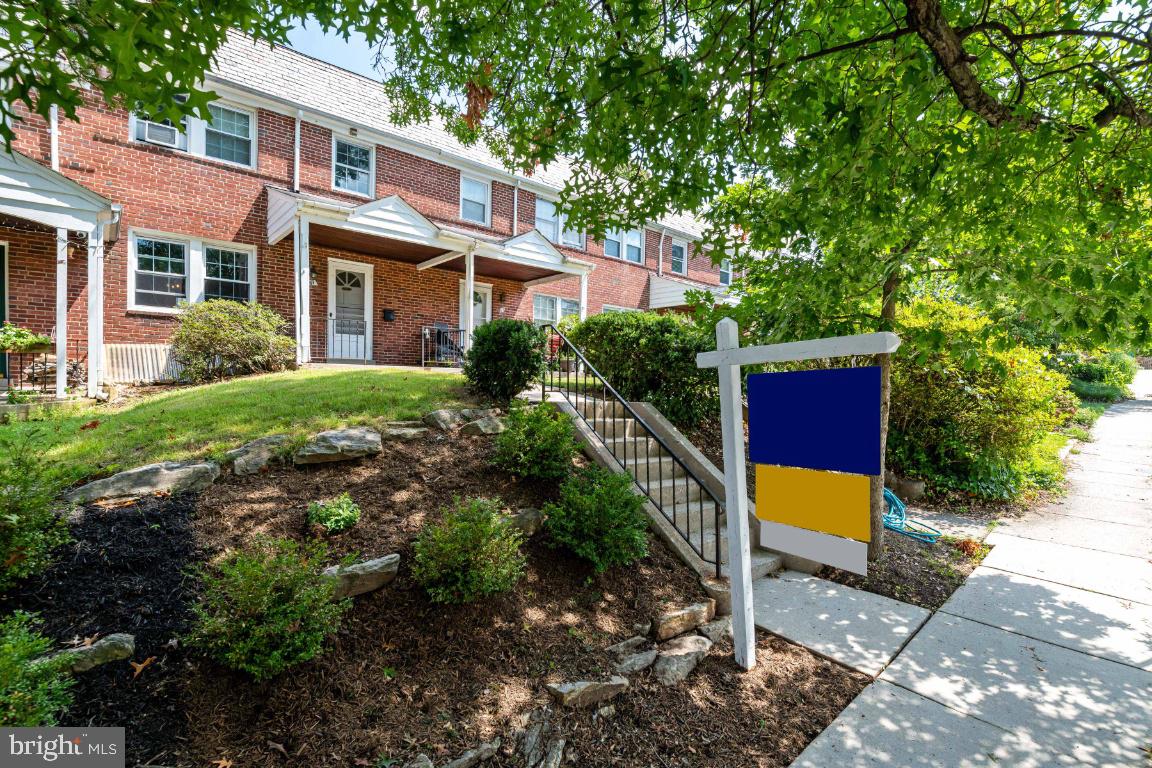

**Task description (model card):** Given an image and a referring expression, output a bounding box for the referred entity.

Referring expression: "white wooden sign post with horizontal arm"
[696,318,900,669]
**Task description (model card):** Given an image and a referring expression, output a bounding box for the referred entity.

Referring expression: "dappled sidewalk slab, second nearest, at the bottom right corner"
[882,613,1152,766]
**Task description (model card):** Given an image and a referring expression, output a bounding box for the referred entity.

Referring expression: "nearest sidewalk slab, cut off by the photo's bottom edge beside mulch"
[791,680,1055,768]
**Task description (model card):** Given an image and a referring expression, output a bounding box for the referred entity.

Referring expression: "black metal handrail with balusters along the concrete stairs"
[541,325,725,576]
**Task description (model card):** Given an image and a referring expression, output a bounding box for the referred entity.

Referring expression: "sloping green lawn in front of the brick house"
[0,368,468,481]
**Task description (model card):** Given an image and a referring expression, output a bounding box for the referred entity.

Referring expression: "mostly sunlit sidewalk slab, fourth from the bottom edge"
[984,531,1152,606]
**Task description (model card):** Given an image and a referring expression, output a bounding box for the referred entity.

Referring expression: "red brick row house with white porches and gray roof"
[0,37,730,395]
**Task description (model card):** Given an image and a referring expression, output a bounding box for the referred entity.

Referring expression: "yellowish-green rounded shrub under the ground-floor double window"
[172,299,296,381]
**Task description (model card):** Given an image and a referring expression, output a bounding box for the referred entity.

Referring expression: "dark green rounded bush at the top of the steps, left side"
[464,319,547,403]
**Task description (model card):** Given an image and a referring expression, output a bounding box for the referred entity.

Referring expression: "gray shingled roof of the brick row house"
[209,32,703,236]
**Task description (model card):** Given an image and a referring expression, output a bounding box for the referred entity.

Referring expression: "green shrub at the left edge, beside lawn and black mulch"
[0,433,68,590]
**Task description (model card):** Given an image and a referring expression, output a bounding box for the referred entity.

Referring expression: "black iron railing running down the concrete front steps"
[541,326,723,576]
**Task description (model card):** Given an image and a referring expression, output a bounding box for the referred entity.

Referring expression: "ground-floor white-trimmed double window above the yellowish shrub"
[128,230,256,313]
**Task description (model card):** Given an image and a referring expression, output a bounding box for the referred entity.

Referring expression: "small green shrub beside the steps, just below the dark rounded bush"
[493,404,579,480]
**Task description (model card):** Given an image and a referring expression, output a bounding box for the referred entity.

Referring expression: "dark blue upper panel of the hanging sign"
[748,366,880,474]
